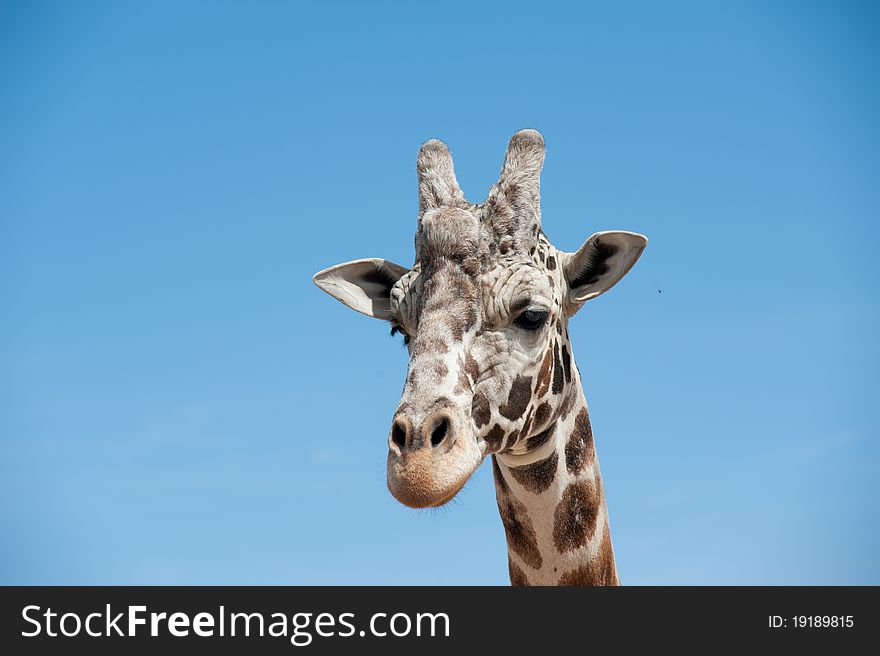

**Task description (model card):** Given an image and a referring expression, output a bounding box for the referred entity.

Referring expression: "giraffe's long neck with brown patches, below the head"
[492,367,619,585]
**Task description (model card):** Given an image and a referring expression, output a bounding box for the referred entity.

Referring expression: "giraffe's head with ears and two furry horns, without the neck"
[314,130,647,508]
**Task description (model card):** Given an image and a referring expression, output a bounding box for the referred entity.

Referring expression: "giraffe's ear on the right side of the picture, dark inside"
[561,230,648,316]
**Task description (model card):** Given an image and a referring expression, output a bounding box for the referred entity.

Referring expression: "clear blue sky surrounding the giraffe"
[0,1,880,584]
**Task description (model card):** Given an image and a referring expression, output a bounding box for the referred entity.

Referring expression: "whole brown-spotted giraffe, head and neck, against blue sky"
[314,130,648,585]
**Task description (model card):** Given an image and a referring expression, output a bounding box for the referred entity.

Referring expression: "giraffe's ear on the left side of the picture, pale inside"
[312,258,409,321]
